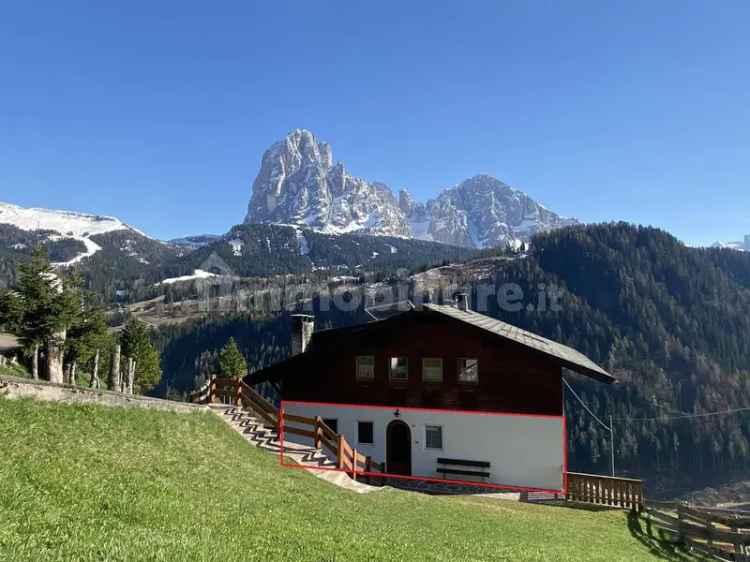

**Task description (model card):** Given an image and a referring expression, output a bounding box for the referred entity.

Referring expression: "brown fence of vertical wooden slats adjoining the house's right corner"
[565,472,643,511]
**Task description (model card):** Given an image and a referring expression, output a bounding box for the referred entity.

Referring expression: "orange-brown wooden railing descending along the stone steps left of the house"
[190,377,385,480]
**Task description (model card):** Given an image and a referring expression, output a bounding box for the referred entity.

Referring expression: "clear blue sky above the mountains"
[0,0,750,243]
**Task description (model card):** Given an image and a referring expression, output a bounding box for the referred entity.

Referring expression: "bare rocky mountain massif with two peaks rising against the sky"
[245,129,577,248]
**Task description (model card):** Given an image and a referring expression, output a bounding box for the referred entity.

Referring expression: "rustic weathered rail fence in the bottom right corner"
[643,501,750,562]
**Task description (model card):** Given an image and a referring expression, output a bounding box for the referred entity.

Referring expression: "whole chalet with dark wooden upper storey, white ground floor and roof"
[246,305,613,489]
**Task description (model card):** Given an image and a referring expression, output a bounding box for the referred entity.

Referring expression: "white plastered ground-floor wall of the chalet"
[284,402,565,490]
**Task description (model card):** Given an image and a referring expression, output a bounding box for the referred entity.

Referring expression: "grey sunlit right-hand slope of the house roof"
[424,304,615,383]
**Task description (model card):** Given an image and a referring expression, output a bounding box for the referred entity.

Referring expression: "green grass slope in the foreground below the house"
[0,399,692,562]
